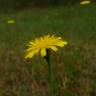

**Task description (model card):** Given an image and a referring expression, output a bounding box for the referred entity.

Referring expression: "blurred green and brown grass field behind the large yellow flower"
[0,4,96,96]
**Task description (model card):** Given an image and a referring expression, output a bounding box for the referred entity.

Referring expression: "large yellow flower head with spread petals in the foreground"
[25,35,67,58]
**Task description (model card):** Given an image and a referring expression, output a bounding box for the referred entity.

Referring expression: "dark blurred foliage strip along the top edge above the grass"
[0,0,80,9]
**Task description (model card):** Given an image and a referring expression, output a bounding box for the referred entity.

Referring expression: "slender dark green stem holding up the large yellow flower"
[45,49,55,96]
